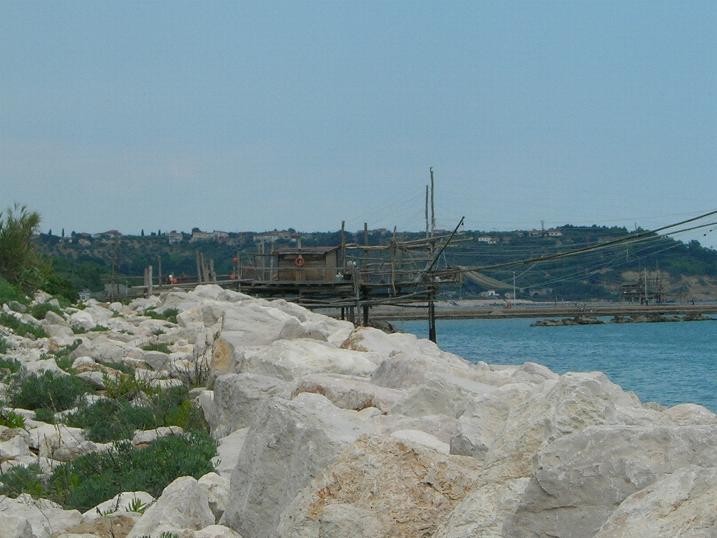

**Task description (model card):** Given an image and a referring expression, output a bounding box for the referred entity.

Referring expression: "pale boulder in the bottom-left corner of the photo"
[0,493,82,538]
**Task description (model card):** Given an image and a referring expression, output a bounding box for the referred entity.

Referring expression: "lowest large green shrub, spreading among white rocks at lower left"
[48,433,216,511]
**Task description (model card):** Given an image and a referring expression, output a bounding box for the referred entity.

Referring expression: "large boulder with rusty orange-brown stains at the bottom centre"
[277,436,478,538]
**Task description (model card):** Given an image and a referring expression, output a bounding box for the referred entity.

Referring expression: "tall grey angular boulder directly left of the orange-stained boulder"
[221,393,371,538]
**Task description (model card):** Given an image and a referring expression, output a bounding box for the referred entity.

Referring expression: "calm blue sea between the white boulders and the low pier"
[392,319,717,412]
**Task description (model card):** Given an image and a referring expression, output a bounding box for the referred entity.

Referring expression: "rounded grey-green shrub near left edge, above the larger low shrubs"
[9,372,93,411]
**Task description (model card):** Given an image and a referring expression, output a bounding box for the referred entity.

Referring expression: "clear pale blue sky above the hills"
[0,0,717,247]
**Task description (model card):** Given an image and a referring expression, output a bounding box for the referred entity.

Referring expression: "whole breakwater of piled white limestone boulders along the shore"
[0,286,717,538]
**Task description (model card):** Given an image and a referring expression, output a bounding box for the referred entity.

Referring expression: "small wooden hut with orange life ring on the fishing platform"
[276,247,339,282]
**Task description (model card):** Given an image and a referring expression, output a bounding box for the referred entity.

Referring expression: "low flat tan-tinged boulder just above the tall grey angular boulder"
[292,374,405,412]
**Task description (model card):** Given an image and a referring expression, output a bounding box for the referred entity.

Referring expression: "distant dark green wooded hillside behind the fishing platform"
[36,225,717,301]
